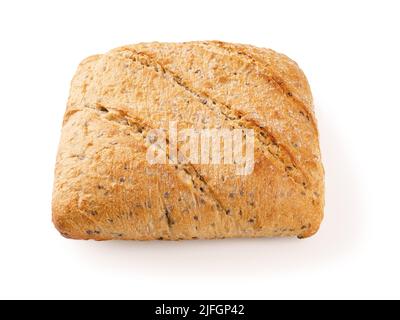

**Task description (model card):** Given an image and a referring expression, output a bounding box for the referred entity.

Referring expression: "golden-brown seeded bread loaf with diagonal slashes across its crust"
[52,41,324,240]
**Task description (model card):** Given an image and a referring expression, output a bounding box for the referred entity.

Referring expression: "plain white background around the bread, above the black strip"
[0,0,400,299]
